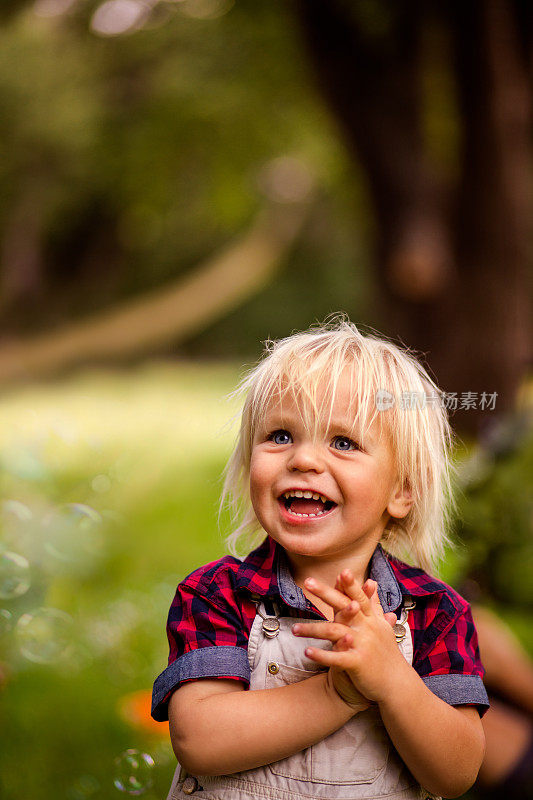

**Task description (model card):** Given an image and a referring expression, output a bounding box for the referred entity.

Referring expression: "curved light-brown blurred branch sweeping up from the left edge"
[0,203,307,384]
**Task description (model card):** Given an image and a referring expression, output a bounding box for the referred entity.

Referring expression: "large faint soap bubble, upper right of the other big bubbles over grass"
[44,503,103,566]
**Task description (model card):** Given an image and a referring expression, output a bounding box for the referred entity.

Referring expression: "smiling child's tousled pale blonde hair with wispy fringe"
[221,316,453,570]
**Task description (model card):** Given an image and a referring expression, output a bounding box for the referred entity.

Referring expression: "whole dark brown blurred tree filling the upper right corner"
[294,0,533,430]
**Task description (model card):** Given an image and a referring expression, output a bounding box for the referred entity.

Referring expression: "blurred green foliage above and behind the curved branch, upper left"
[0,2,365,352]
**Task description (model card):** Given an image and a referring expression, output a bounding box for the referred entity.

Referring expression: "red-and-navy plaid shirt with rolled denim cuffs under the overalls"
[152,536,488,721]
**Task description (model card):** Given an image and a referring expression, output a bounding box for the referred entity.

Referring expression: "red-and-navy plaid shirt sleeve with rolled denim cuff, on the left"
[152,573,250,722]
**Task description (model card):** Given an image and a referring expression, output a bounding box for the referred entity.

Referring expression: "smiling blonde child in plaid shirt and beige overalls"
[153,320,487,800]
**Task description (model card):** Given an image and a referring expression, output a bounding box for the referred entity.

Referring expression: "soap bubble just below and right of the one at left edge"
[16,608,73,664]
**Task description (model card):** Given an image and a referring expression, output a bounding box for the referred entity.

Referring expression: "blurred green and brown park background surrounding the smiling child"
[0,0,533,800]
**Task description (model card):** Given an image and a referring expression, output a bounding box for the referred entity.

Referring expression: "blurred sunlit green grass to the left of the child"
[0,364,237,800]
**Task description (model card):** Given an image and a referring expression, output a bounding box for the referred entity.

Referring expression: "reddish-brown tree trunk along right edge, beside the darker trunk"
[447,0,532,424]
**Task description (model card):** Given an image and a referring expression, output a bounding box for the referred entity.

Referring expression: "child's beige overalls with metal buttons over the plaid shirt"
[167,598,440,800]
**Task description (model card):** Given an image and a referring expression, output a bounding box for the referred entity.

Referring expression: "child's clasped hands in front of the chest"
[292,569,408,713]
